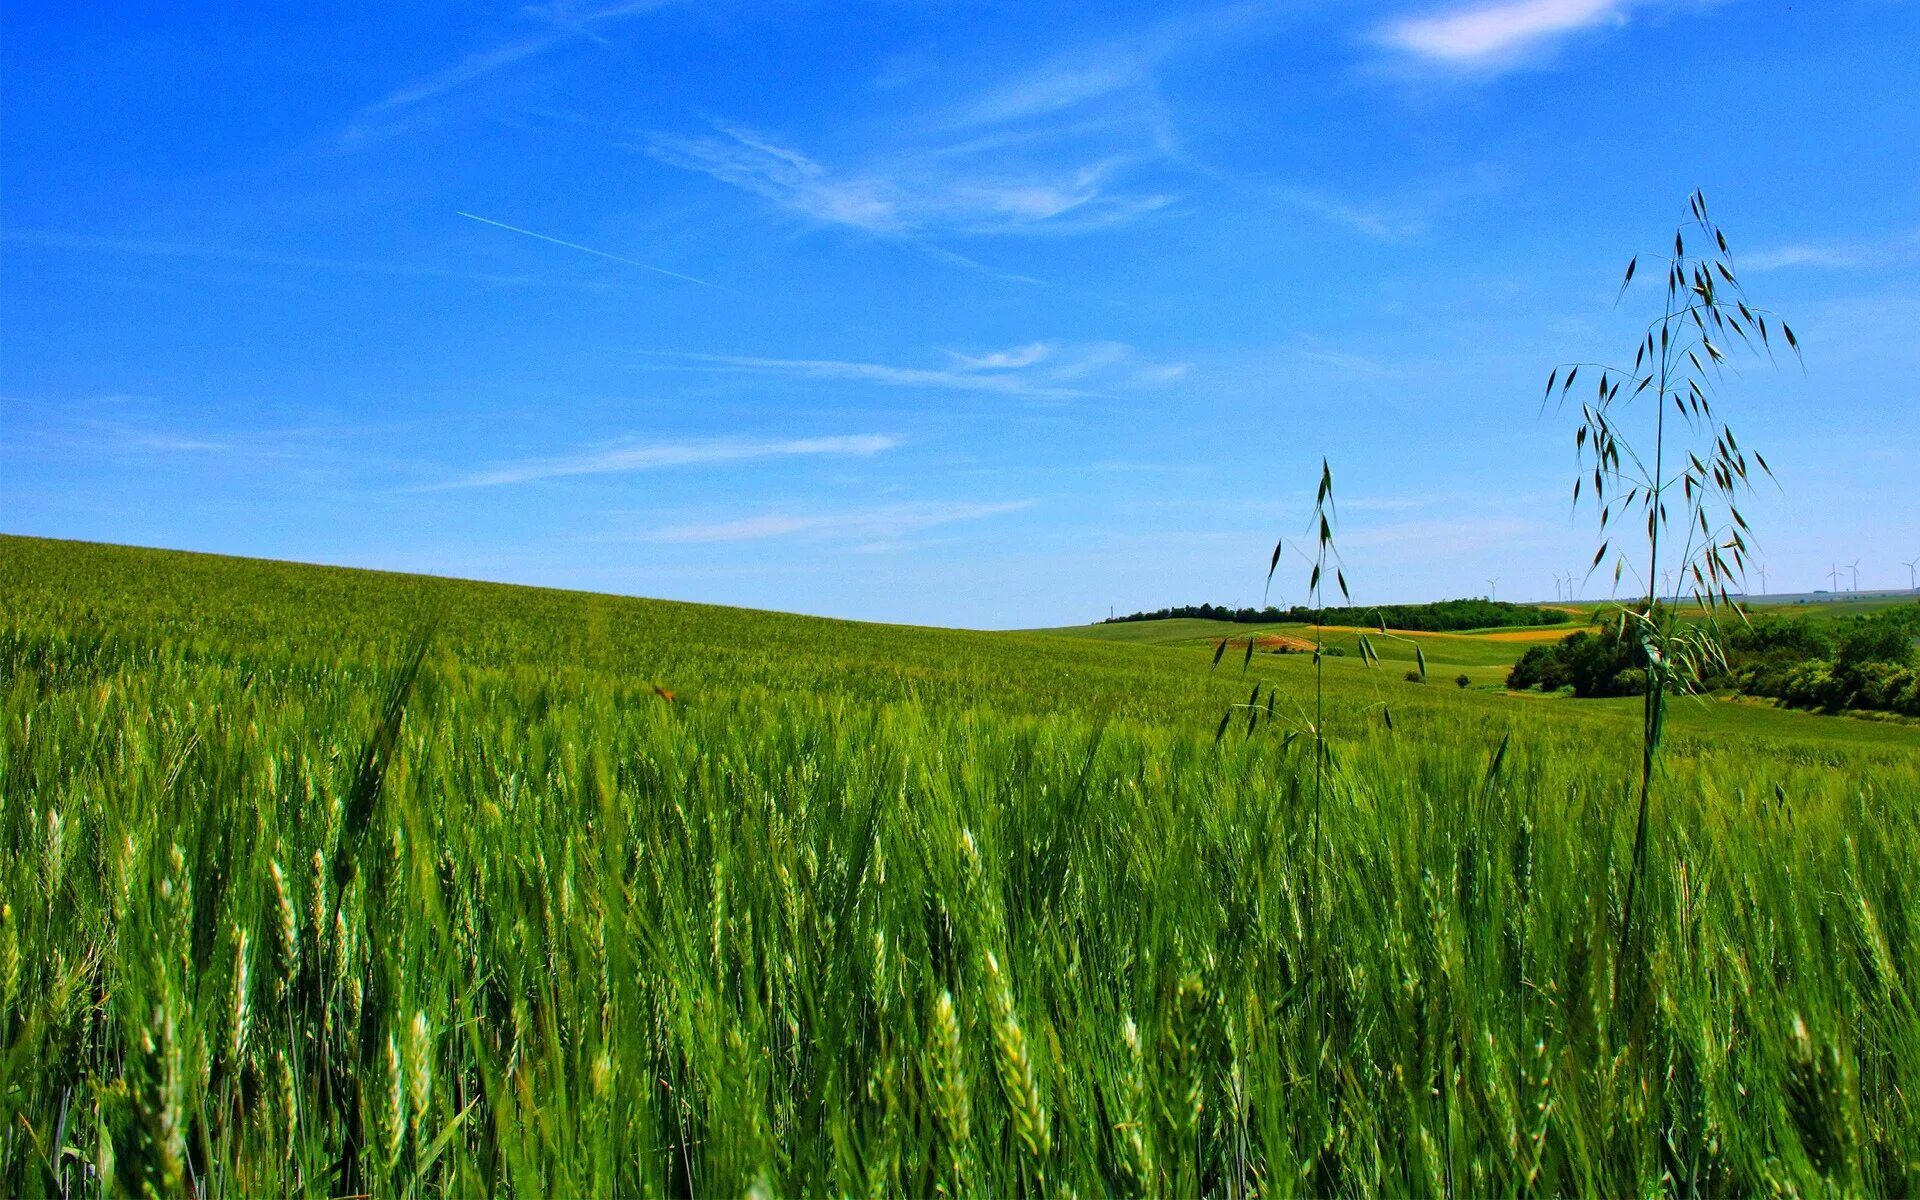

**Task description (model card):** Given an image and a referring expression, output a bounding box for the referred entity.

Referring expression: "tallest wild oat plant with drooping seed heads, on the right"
[1546,192,1799,964]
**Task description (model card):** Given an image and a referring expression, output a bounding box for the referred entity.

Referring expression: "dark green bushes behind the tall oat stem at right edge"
[1507,605,1920,716]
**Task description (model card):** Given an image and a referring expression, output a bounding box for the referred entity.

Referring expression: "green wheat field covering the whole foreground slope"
[0,538,1920,1196]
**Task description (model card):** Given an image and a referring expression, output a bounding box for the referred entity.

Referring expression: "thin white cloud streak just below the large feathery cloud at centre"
[641,342,1188,399]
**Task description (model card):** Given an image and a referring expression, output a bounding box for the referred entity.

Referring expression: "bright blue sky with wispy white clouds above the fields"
[0,0,1920,626]
